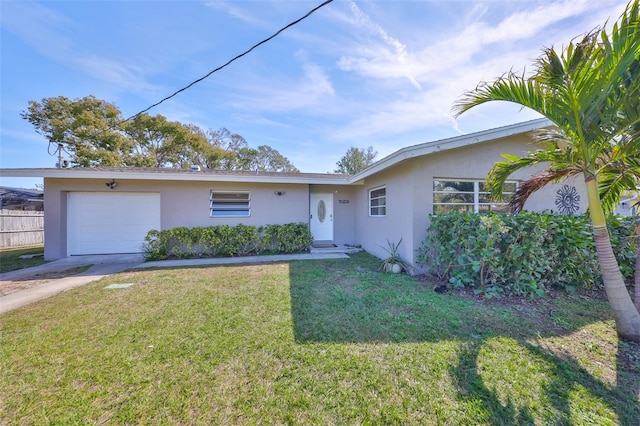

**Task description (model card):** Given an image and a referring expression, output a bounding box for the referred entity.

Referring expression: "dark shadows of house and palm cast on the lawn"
[290,254,640,426]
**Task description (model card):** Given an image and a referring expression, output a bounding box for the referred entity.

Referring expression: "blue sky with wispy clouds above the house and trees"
[0,0,627,187]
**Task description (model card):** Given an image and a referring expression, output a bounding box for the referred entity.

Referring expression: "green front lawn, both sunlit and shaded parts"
[0,254,640,426]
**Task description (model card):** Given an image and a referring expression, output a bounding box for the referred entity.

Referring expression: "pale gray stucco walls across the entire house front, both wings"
[45,131,586,265]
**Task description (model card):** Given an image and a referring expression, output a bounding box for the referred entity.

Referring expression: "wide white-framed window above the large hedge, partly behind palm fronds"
[433,179,517,214]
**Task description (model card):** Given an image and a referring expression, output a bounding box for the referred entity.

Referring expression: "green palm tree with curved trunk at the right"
[454,0,640,342]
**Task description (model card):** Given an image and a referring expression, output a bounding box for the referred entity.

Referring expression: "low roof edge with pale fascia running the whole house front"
[0,118,552,185]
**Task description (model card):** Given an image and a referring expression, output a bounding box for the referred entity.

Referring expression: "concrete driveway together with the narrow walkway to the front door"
[0,251,349,314]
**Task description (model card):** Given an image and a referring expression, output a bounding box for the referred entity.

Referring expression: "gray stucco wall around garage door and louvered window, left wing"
[44,178,309,260]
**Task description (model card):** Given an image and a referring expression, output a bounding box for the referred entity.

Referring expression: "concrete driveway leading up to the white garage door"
[0,254,144,314]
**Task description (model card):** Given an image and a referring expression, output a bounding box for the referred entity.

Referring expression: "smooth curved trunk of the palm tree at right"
[586,178,640,343]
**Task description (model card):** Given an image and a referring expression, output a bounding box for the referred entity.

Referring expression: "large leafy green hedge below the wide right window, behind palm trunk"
[417,212,637,297]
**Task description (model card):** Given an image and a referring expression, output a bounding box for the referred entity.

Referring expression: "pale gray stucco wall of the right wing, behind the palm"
[355,135,586,271]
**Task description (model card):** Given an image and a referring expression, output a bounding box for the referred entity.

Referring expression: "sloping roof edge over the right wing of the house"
[349,118,553,183]
